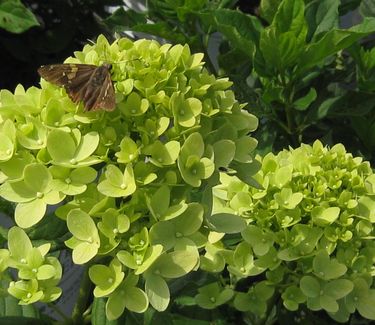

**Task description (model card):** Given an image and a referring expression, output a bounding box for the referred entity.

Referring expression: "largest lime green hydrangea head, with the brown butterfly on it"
[0,36,257,319]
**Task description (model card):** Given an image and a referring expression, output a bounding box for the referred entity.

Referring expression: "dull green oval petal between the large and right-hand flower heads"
[207,213,246,234]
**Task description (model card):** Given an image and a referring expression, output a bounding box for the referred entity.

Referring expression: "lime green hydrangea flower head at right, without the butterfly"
[209,141,375,322]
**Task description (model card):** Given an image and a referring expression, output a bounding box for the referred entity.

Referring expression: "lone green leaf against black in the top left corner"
[0,0,39,34]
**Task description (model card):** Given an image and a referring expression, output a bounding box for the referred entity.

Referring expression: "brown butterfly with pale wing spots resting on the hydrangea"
[38,63,116,111]
